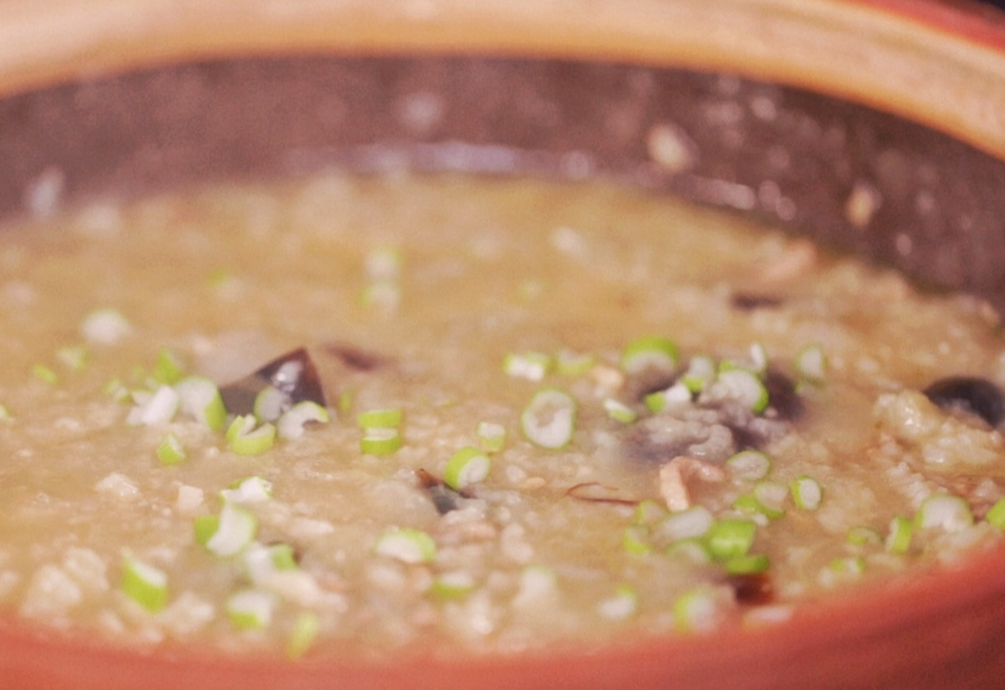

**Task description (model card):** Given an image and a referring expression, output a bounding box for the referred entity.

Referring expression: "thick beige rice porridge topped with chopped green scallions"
[0,176,1005,658]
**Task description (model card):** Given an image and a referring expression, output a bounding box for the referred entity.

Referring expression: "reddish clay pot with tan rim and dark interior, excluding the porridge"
[0,0,1005,690]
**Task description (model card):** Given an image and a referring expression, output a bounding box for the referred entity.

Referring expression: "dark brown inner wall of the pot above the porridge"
[0,56,1005,308]
